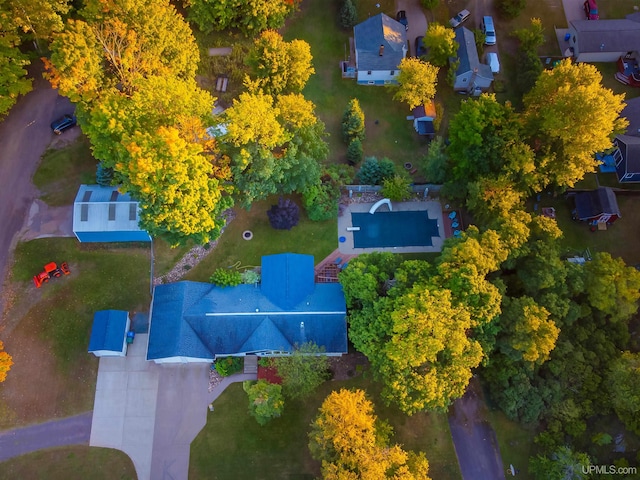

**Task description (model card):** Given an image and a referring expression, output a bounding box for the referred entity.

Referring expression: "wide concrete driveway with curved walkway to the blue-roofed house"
[89,334,257,480]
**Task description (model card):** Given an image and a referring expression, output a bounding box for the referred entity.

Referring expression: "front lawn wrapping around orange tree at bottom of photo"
[189,377,460,480]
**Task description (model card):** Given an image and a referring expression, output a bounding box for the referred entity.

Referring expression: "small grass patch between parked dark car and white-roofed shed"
[33,136,97,207]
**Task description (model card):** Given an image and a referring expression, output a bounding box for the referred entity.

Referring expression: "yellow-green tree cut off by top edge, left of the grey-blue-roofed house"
[184,0,300,36]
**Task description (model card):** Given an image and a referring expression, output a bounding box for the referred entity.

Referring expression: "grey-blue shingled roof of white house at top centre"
[353,13,407,71]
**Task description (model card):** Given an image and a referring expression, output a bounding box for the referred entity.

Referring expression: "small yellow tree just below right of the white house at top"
[389,57,439,110]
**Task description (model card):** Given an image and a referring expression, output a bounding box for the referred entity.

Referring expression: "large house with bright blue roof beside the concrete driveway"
[147,253,347,363]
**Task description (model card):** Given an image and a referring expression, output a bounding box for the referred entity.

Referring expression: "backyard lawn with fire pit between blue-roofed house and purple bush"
[185,197,338,281]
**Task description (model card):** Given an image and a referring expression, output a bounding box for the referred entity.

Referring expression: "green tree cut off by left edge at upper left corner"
[0,6,31,118]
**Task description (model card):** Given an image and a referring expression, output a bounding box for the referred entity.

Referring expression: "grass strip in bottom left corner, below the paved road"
[0,445,137,480]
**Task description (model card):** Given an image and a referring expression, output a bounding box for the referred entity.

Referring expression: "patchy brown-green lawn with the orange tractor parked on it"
[0,238,150,428]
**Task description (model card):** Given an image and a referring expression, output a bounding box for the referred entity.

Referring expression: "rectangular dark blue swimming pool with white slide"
[351,210,440,248]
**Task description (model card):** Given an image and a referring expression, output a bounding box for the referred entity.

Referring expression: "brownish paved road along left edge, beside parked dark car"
[0,61,72,313]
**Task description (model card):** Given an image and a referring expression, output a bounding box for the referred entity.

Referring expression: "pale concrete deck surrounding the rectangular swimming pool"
[338,200,450,255]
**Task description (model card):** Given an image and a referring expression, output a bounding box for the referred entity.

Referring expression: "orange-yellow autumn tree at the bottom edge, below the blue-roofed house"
[309,389,429,480]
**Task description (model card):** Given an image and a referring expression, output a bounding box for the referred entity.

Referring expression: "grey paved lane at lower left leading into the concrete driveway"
[0,412,93,462]
